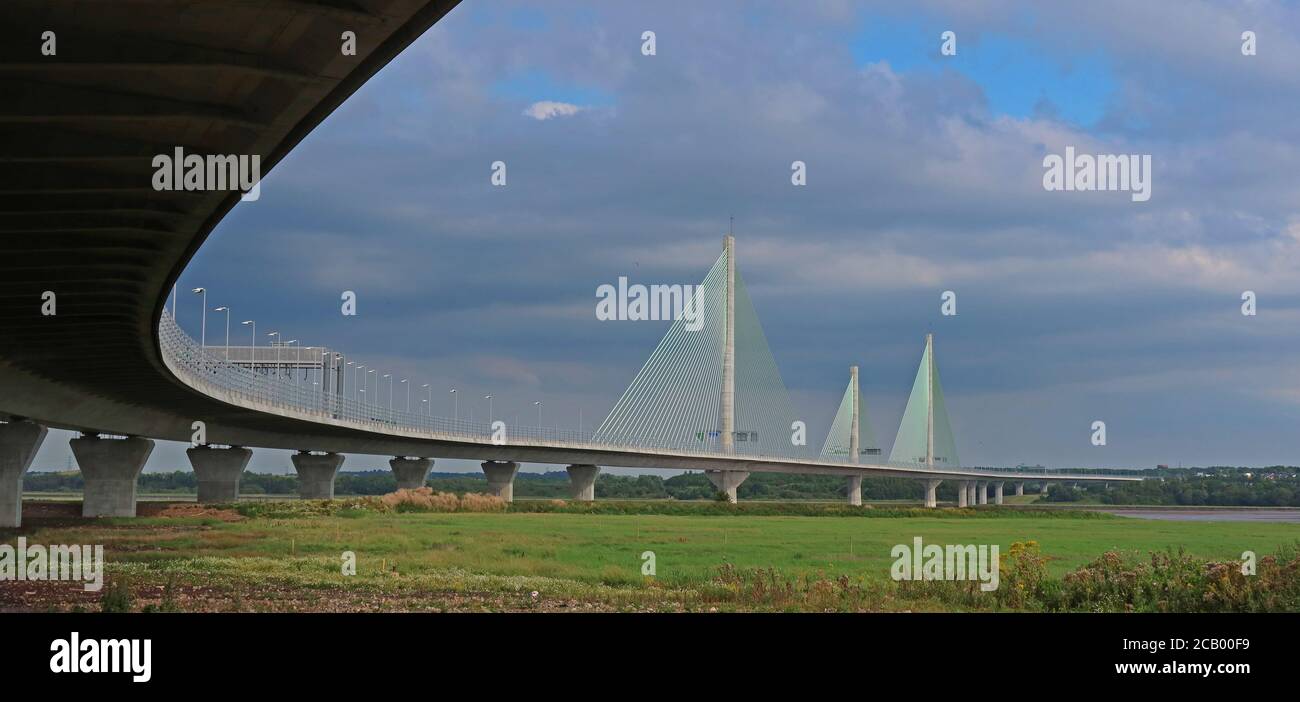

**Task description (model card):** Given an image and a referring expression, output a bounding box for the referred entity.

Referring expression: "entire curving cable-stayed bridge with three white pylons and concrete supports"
[0,0,1135,527]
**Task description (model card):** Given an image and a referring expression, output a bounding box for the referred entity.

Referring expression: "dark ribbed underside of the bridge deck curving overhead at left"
[0,0,458,445]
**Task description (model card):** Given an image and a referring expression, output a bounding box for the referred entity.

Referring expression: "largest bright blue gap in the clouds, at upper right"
[850,18,1117,127]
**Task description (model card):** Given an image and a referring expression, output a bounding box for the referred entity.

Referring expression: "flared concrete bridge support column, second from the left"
[69,434,153,516]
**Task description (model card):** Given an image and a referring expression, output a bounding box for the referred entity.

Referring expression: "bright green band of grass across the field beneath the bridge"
[9,510,1300,584]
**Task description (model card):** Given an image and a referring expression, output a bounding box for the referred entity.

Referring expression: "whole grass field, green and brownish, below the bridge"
[0,503,1300,610]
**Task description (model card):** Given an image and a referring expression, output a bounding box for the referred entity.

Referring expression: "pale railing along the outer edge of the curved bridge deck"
[159,313,1144,477]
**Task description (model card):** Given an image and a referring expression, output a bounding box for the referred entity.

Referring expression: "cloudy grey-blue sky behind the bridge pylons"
[38,0,1300,472]
